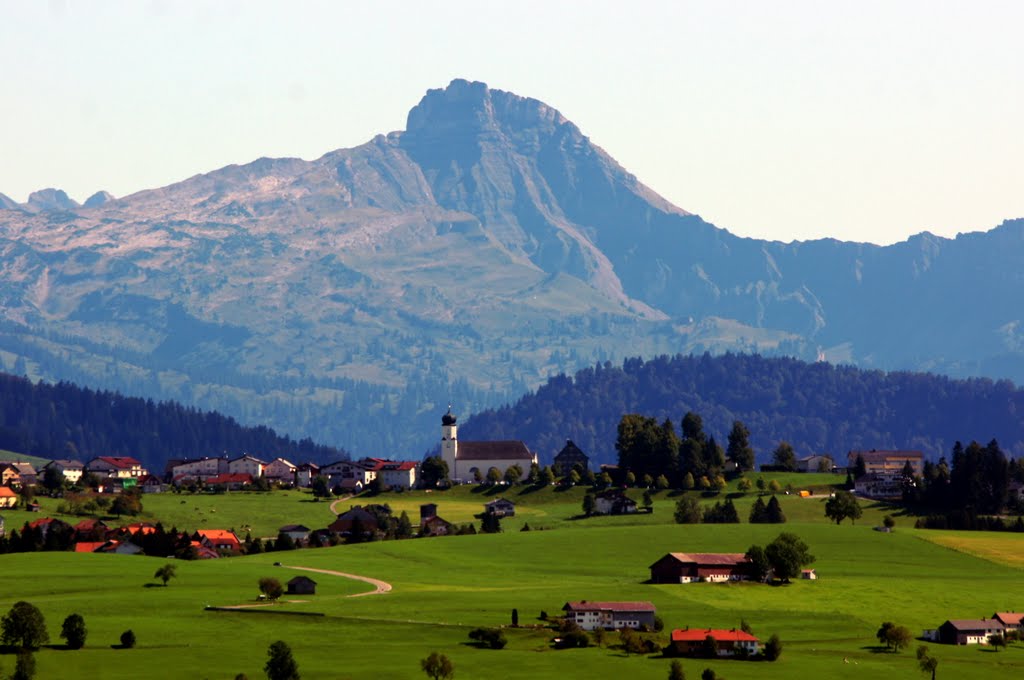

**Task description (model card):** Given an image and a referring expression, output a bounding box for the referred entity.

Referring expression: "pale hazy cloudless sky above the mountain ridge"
[0,0,1024,243]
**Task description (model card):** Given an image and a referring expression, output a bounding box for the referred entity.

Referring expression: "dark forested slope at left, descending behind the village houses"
[0,374,347,472]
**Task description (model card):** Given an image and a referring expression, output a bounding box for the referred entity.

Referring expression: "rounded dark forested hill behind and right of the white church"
[460,353,1024,463]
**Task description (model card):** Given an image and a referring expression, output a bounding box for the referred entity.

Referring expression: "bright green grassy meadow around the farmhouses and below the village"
[0,475,1024,680]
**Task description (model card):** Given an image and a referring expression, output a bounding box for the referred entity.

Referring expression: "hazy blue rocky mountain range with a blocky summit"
[0,80,1024,456]
